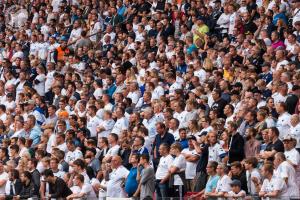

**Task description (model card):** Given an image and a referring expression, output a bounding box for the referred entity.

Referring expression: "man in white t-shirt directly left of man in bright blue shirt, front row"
[107,156,129,198]
